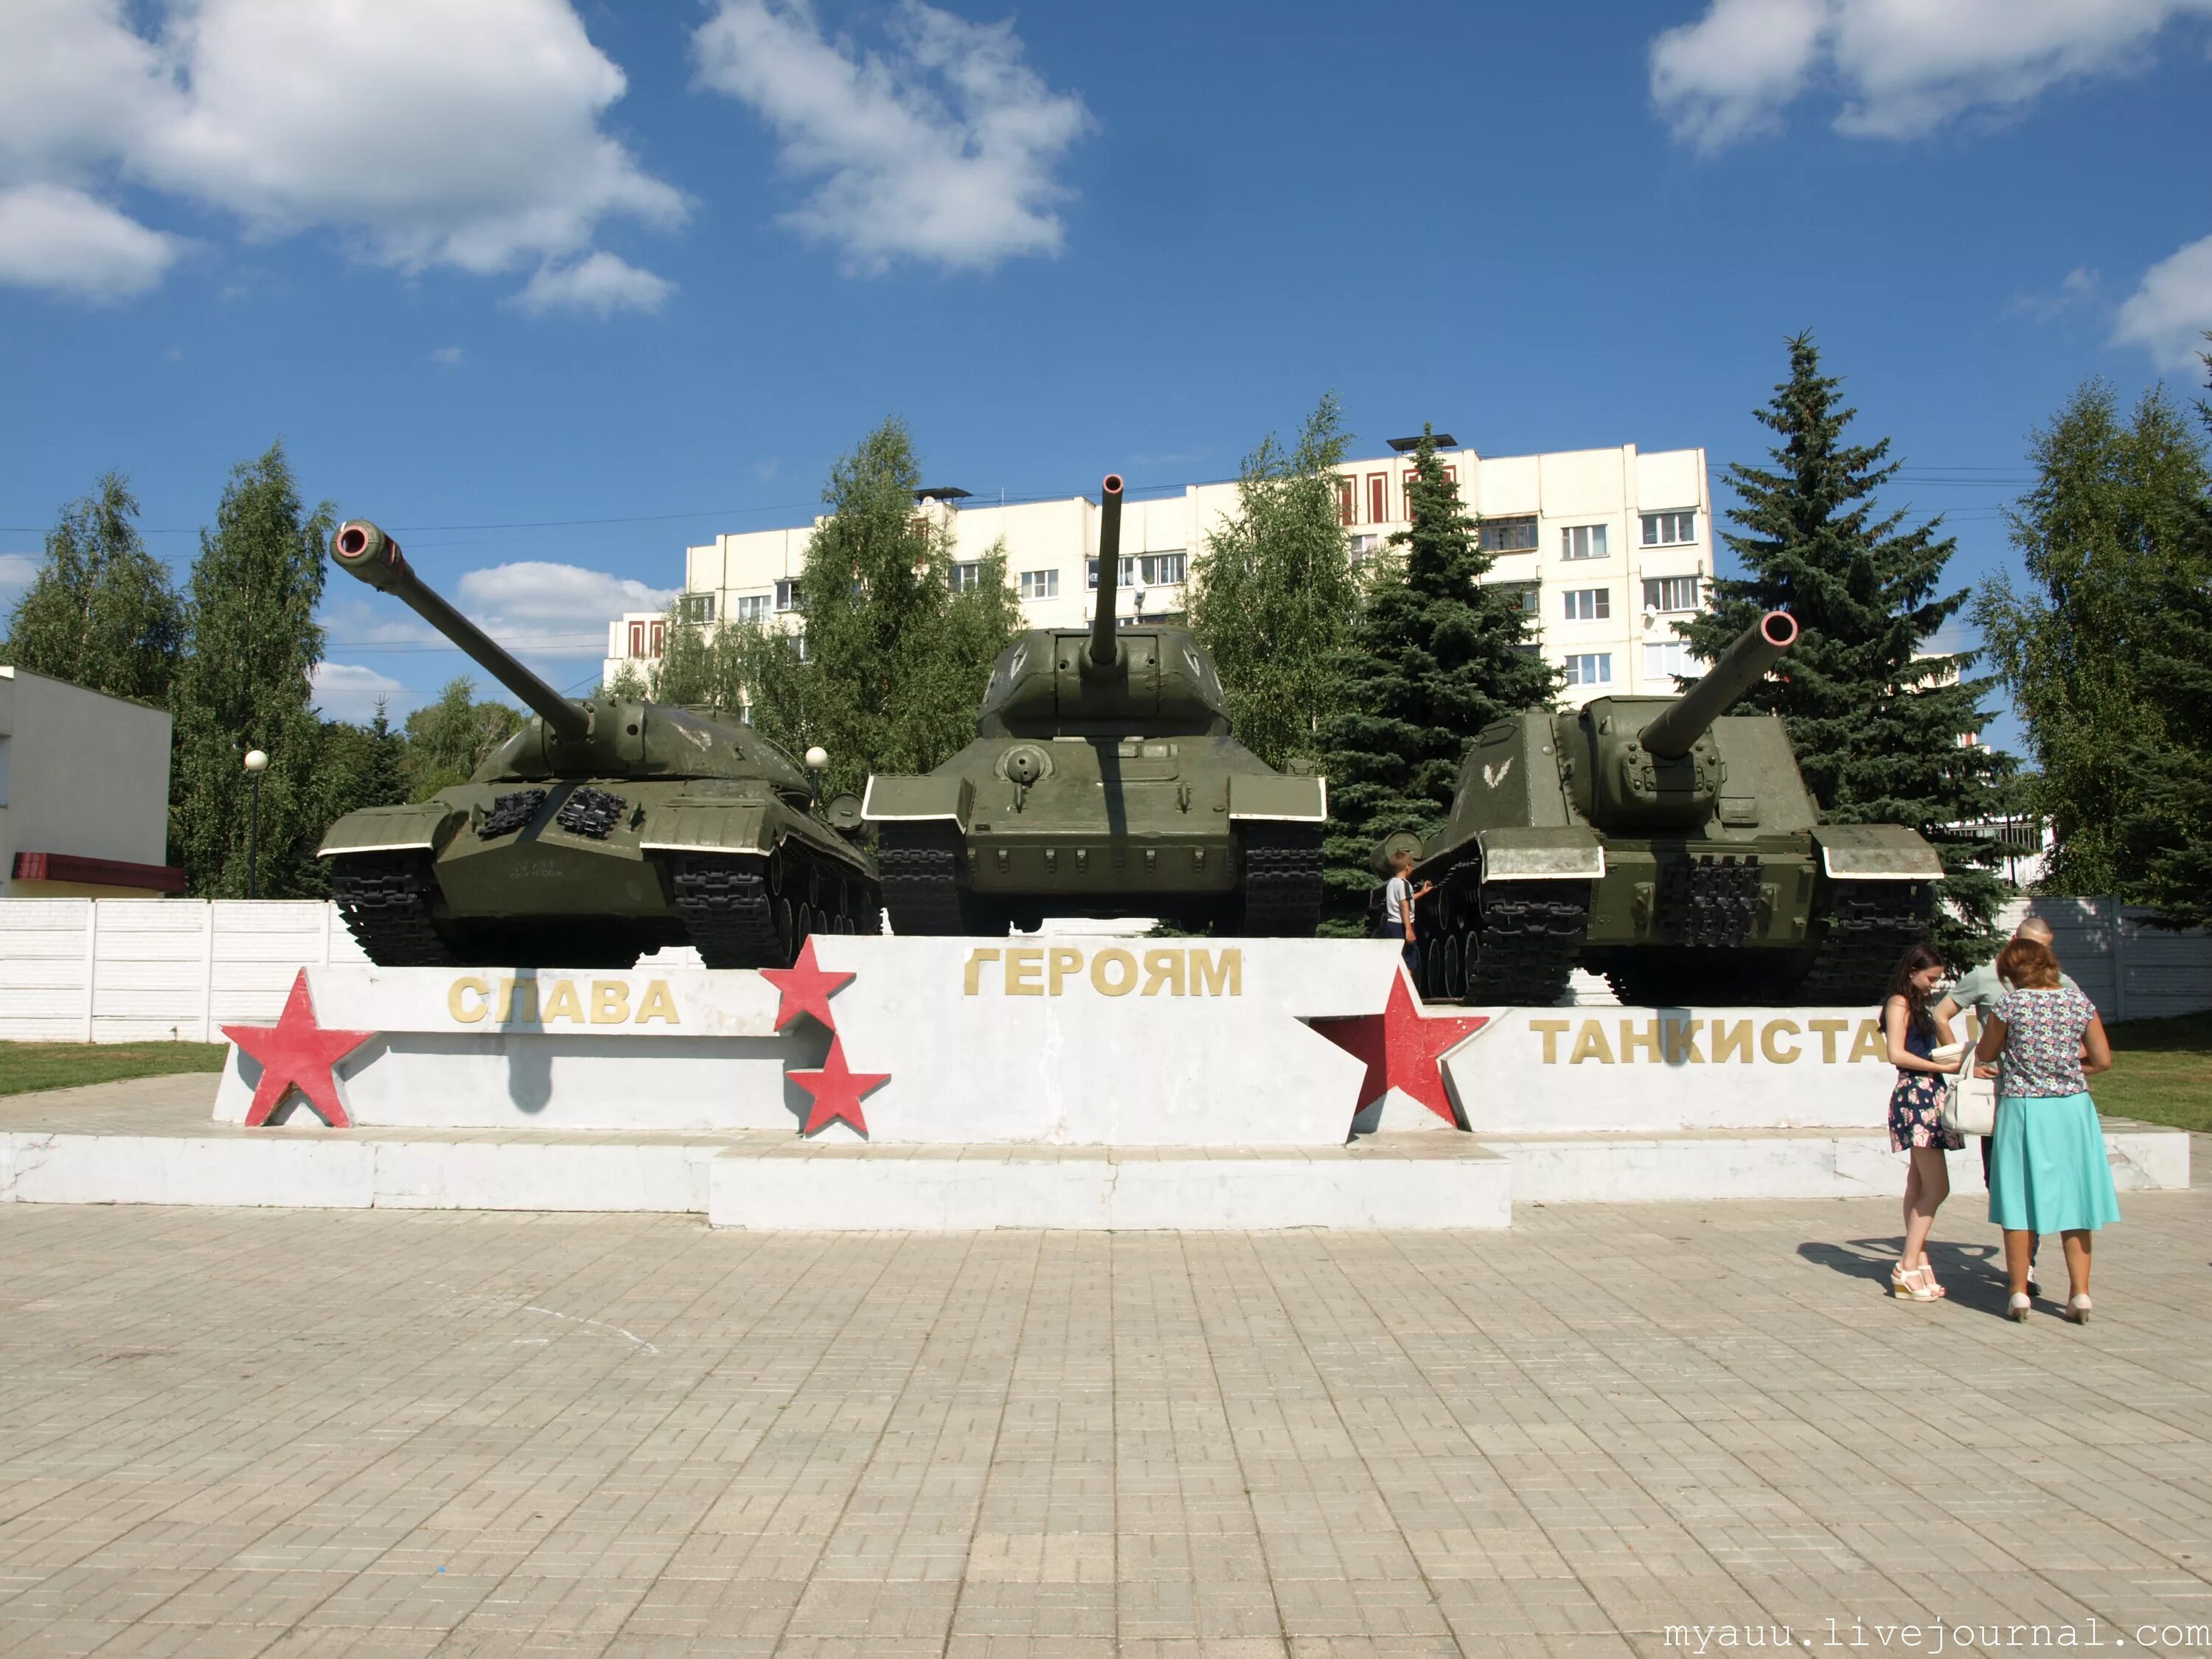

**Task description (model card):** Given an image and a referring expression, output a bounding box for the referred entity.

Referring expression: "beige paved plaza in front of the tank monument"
[0,1148,2212,1659]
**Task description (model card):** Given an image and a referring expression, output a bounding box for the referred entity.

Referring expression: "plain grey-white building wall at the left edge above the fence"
[0,666,170,894]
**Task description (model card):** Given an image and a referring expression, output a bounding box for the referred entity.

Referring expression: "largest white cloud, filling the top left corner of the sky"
[0,0,684,305]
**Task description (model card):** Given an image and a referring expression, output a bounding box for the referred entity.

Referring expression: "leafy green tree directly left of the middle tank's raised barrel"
[734,416,1022,790]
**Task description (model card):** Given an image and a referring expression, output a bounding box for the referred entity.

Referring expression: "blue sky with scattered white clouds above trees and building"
[0,0,2212,752]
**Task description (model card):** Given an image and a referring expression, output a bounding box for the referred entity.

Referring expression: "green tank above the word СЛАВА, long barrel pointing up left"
[319,520,880,967]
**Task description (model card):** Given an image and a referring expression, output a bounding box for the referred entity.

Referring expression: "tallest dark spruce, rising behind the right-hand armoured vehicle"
[1677,334,2004,967]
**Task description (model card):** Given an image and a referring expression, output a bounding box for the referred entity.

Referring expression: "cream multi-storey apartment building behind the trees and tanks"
[606,445,1712,703]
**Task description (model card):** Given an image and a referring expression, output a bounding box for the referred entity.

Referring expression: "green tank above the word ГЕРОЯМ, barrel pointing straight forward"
[863,476,1327,936]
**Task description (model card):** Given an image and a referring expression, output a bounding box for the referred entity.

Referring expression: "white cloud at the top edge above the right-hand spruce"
[1650,0,2212,150]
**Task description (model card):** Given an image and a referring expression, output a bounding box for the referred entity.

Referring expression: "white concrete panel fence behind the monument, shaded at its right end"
[0,898,2212,1042]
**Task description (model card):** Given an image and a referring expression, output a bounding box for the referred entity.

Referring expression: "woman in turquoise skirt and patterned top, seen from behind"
[1973,938,2119,1325]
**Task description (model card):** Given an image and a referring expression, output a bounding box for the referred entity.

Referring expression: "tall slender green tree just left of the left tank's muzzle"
[170,445,332,898]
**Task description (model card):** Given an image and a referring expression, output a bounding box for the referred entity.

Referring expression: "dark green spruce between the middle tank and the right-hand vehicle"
[1323,427,1559,933]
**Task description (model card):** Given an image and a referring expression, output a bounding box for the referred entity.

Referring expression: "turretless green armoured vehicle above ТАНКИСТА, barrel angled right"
[1378,611,1942,1006]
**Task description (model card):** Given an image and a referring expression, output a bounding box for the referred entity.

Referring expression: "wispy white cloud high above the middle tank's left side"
[692,0,1091,272]
